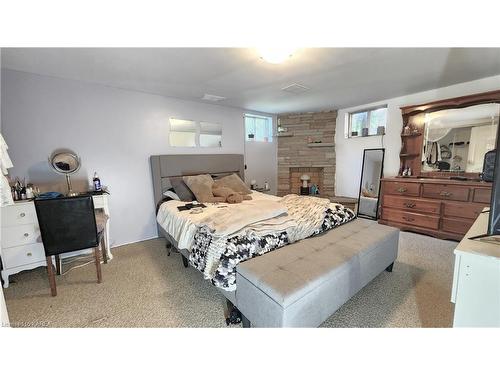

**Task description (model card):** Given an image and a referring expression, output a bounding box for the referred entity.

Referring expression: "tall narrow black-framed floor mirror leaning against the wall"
[358,148,385,220]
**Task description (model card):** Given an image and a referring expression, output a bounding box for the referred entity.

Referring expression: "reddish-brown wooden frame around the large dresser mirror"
[400,90,500,179]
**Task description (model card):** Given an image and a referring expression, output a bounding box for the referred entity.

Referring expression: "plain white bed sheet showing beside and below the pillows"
[156,190,281,250]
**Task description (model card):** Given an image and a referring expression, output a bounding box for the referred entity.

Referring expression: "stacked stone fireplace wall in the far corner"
[277,111,337,197]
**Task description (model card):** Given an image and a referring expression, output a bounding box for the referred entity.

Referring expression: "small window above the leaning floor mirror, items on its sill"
[348,106,387,137]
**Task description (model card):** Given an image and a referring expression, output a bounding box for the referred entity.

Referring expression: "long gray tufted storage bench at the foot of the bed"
[236,218,399,327]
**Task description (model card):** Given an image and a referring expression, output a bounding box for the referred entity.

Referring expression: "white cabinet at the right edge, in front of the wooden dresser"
[451,213,500,327]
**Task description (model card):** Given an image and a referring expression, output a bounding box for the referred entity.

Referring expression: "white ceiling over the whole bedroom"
[2,48,500,113]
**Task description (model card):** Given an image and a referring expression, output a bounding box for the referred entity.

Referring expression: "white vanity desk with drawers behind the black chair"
[0,194,113,288]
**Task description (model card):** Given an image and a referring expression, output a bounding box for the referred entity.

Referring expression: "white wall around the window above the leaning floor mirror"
[335,75,500,197]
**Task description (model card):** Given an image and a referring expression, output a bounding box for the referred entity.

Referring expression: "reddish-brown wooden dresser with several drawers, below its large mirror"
[379,177,491,240]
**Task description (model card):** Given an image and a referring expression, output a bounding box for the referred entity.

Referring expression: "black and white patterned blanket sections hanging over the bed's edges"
[189,204,356,291]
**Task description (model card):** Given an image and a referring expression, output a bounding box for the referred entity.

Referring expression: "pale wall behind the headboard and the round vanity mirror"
[1,70,276,246]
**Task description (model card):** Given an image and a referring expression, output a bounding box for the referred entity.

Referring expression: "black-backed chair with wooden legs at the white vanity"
[35,195,107,297]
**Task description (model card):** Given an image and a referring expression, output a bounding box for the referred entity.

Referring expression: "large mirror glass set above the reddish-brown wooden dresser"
[421,103,500,173]
